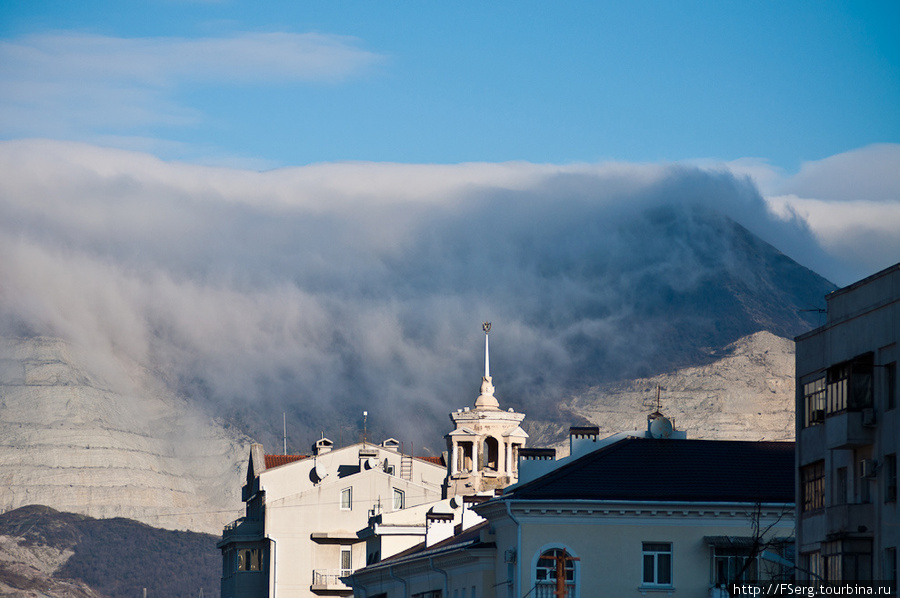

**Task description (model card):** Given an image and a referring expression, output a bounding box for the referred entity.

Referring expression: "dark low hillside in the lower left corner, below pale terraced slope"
[0,505,221,598]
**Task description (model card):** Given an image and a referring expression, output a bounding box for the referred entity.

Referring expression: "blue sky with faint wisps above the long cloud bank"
[0,0,900,172]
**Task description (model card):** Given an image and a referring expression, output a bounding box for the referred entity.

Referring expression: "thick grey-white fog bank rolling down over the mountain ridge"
[0,141,834,452]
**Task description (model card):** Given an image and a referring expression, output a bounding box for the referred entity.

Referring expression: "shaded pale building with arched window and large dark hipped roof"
[352,435,794,598]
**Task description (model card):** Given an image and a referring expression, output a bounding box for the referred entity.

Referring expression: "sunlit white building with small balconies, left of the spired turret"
[219,439,446,598]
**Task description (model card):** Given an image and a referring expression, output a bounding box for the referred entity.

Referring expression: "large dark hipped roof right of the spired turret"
[504,438,794,503]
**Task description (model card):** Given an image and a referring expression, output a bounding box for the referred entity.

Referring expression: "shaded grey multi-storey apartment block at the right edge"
[796,264,900,581]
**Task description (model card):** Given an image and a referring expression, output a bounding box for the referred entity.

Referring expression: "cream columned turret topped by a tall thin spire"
[446,322,528,496]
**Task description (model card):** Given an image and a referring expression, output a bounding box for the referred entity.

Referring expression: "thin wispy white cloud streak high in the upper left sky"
[0,32,382,137]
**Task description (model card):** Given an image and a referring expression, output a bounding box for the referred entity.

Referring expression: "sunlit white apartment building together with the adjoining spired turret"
[218,323,527,598]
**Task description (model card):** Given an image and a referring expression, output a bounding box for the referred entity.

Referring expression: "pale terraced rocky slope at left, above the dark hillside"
[0,337,247,534]
